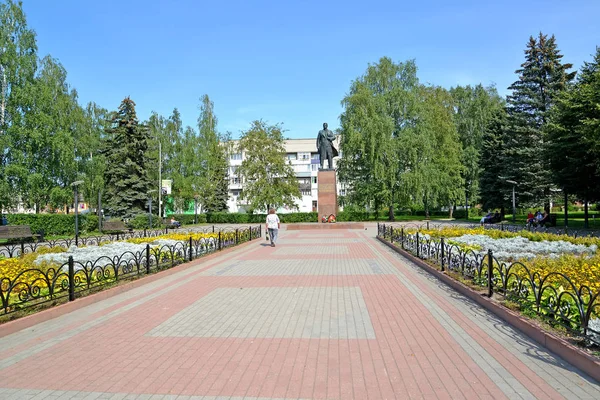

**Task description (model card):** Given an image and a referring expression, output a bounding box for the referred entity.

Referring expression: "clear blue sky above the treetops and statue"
[23,0,600,138]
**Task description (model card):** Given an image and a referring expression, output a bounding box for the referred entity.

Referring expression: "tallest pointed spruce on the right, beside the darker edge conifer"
[504,33,575,209]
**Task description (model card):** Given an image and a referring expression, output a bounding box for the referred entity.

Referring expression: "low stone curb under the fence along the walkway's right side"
[377,237,600,381]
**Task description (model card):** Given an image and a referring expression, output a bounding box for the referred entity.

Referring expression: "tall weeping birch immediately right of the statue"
[338,57,419,219]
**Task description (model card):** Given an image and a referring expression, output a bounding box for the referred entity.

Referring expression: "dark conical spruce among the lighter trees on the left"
[104,97,151,217]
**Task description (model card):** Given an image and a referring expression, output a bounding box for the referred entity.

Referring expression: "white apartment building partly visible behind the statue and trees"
[227,138,345,213]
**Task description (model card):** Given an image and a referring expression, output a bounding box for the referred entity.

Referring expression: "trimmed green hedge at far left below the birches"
[5,214,98,235]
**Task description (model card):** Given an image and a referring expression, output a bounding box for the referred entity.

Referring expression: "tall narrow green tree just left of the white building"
[196,94,229,212]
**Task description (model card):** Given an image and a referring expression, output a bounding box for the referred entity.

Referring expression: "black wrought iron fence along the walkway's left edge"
[0,225,262,315]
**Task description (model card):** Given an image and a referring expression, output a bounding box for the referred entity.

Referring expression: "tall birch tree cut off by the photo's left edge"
[0,0,37,210]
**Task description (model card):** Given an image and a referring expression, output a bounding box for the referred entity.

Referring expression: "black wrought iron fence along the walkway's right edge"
[377,224,600,346]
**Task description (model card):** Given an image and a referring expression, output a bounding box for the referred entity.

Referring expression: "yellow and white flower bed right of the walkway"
[378,225,600,346]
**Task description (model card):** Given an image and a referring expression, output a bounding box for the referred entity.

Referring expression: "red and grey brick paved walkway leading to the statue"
[0,227,600,400]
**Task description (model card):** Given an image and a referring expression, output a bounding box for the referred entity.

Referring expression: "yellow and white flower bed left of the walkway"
[0,227,260,315]
